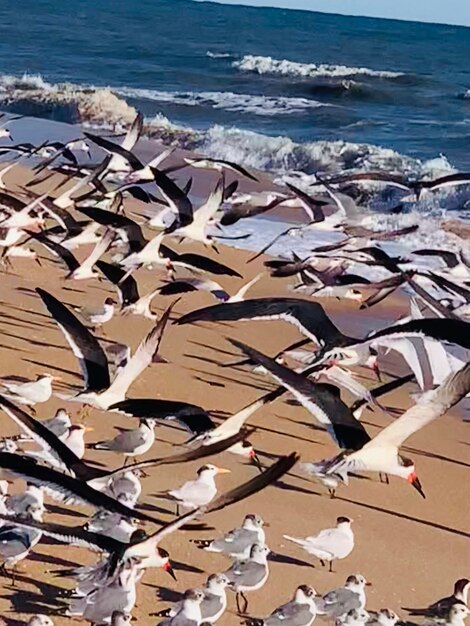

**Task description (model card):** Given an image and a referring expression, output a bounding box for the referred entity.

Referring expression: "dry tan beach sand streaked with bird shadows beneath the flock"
[0,161,470,626]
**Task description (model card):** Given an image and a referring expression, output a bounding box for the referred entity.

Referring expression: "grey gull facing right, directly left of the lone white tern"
[193,513,266,559]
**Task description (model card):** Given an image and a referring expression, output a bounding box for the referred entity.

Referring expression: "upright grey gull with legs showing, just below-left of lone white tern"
[225,543,270,615]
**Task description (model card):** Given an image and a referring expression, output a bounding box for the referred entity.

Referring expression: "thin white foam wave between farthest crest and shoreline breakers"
[113,87,332,116]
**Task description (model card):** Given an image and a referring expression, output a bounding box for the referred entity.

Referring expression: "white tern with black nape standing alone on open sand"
[283,516,354,572]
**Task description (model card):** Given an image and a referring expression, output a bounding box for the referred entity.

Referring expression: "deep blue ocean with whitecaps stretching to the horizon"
[0,0,470,171]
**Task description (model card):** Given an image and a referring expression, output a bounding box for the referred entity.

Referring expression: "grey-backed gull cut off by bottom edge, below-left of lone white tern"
[246,585,317,626]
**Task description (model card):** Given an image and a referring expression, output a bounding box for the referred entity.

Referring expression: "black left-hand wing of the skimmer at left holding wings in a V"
[36,287,111,391]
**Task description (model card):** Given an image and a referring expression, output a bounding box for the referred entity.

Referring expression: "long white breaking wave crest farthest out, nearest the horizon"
[232,54,404,79]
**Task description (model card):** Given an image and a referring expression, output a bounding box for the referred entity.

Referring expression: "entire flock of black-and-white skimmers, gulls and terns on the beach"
[0,115,470,626]
